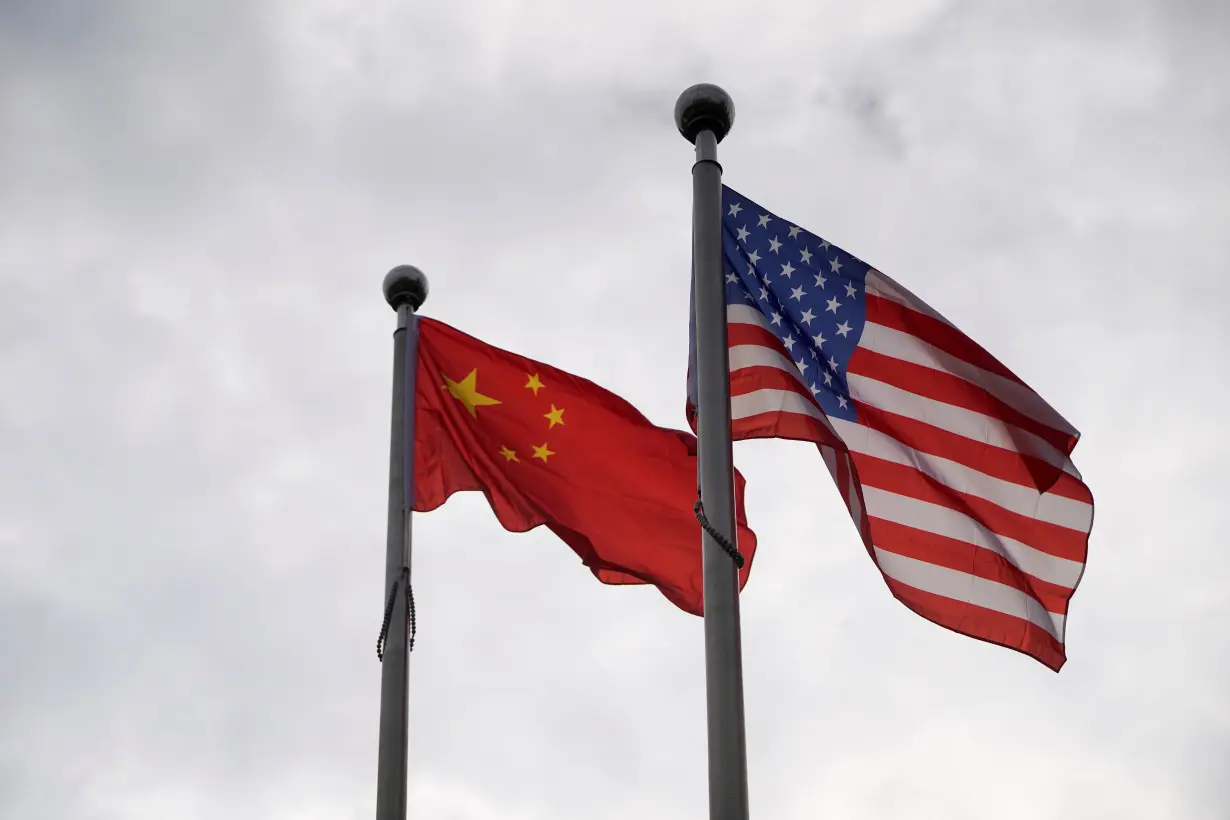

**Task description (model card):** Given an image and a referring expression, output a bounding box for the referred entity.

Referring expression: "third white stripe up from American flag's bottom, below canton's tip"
[829,418,1093,534]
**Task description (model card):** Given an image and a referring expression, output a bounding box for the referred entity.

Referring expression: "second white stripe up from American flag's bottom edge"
[862,486,1084,589]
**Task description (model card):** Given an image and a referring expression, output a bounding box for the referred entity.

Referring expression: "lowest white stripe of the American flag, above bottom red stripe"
[876,547,1064,643]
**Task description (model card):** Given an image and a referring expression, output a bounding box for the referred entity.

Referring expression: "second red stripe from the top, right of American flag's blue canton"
[850,348,1076,455]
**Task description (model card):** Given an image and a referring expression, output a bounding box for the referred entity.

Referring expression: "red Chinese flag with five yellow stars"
[415,318,756,615]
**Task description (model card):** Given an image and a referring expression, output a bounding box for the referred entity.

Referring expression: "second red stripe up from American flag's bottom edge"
[867,518,1074,615]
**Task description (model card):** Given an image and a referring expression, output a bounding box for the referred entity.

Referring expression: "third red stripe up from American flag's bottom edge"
[854,452,1089,563]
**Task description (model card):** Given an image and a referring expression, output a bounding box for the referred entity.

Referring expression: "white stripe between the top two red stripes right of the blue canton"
[859,322,1076,435]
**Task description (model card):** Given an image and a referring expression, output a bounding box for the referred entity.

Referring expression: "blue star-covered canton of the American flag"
[722,186,867,422]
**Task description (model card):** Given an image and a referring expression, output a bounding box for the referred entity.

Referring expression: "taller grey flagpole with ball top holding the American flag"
[675,84,748,820]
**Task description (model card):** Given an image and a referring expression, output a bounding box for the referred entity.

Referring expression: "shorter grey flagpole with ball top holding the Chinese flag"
[376,264,427,820]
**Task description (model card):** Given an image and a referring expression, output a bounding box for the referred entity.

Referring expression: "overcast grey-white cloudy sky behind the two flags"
[0,0,1230,820]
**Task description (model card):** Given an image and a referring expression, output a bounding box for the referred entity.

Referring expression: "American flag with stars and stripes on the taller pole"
[688,188,1093,671]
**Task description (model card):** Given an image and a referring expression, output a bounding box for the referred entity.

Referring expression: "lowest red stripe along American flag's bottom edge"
[884,575,1066,672]
